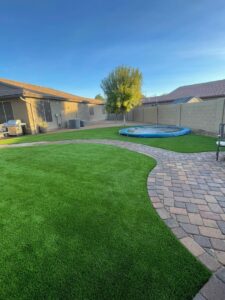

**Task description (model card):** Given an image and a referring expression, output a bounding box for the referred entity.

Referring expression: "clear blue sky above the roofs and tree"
[0,0,225,97]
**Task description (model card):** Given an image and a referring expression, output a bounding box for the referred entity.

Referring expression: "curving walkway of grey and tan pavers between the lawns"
[0,139,225,300]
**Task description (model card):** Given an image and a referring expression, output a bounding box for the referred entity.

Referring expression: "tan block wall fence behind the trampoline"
[122,99,225,134]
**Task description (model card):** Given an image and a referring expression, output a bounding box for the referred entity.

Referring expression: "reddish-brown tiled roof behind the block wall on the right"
[142,79,225,104]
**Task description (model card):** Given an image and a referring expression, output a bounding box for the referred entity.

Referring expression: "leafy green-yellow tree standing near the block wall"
[101,66,142,124]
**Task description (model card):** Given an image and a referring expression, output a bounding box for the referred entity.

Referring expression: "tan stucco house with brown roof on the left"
[0,78,106,133]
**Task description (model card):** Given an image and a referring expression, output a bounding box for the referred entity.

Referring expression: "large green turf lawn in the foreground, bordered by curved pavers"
[0,144,210,300]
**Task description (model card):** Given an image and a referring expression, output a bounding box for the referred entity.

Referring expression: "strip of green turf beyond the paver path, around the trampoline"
[0,127,216,152]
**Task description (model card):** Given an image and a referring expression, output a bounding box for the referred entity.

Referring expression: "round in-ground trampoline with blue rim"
[119,125,191,138]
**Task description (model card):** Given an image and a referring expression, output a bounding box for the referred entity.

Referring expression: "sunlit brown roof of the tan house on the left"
[0,78,103,104]
